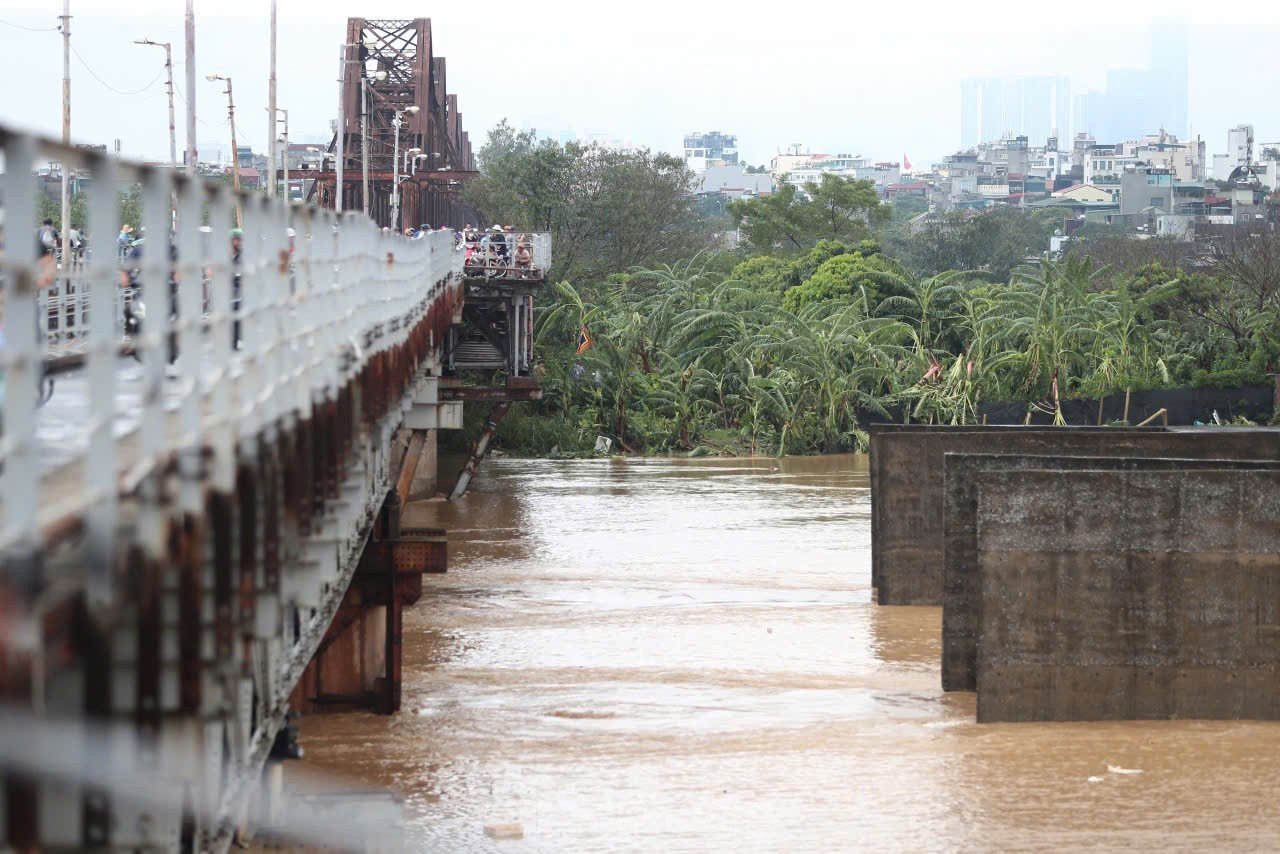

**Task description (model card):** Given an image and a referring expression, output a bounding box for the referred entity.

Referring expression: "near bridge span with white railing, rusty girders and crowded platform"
[0,110,550,850]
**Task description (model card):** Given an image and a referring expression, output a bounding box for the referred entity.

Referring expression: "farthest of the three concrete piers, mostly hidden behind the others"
[870,425,1280,606]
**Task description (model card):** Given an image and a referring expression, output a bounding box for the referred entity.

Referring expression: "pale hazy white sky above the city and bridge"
[0,0,1280,166]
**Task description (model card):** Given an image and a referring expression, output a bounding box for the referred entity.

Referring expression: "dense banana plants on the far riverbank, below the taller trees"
[503,237,1280,453]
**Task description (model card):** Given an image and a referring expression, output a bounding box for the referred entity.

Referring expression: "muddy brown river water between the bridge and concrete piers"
[294,456,1280,851]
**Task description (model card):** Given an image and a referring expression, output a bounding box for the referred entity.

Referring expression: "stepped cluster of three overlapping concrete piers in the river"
[872,425,1280,722]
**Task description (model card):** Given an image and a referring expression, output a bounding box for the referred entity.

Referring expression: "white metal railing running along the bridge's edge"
[0,127,462,549]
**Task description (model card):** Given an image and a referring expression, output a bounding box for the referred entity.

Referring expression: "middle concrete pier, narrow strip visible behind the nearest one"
[942,453,1280,691]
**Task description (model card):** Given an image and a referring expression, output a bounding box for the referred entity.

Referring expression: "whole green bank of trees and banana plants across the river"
[472,128,1280,455]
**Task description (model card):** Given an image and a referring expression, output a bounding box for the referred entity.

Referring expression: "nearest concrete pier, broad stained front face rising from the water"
[977,470,1280,722]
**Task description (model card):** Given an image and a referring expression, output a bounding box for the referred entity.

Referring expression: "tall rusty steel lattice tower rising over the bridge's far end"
[315,18,476,228]
